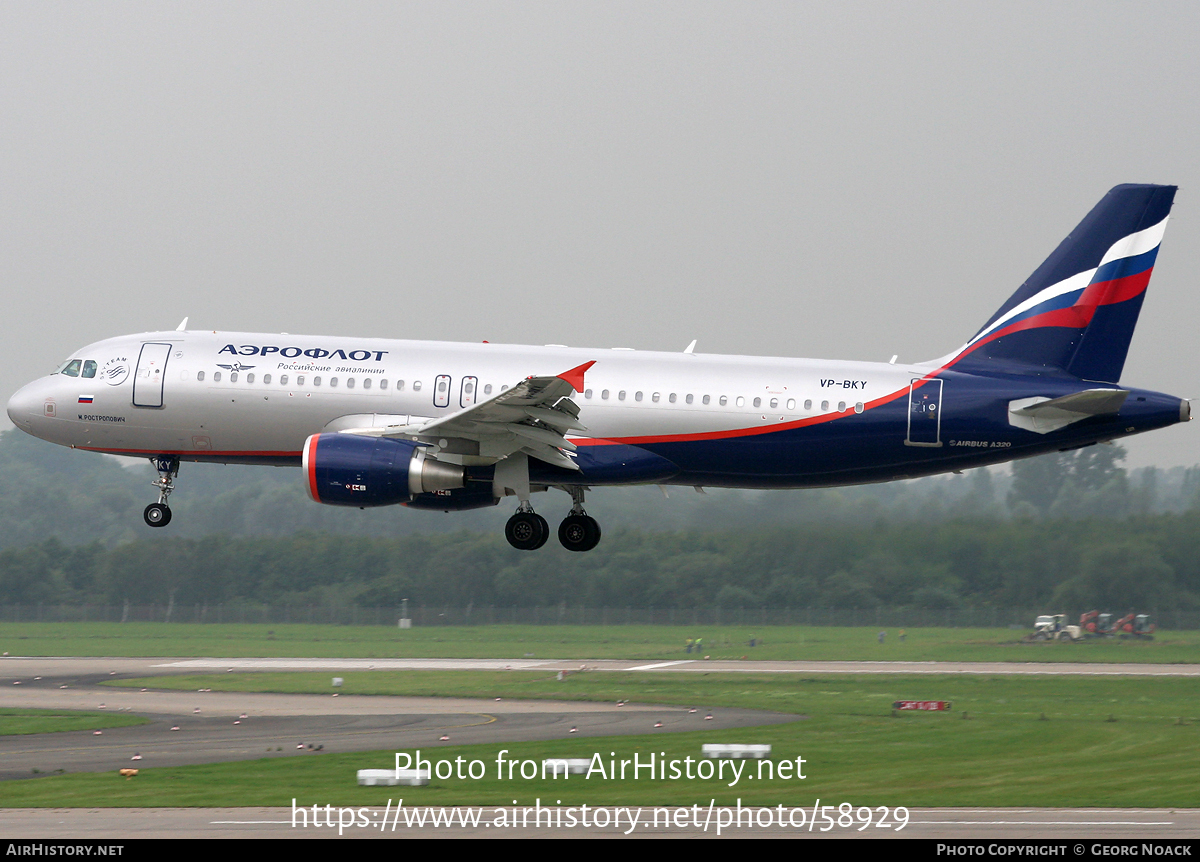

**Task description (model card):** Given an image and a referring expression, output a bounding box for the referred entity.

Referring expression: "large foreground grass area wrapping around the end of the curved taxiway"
[0,671,1200,807]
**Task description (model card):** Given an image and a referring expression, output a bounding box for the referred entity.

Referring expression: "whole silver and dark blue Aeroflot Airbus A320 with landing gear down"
[8,185,1190,551]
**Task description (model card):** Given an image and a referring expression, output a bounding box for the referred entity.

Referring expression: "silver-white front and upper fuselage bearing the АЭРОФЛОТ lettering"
[8,331,928,462]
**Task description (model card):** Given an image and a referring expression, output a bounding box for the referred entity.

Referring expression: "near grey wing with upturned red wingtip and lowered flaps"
[342,361,595,469]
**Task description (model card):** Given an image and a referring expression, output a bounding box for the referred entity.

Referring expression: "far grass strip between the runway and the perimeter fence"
[0,623,1200,663]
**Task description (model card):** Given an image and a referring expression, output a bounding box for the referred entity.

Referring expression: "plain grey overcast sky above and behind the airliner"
[0,0,1200,466]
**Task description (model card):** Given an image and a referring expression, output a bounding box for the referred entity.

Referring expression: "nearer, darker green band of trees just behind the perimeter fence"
[0,513,1200,612]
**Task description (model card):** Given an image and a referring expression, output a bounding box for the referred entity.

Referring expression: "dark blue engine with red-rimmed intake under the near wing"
[302,433,466,507]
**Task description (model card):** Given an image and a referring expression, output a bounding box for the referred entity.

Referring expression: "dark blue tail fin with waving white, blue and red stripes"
[952,184,1176,383]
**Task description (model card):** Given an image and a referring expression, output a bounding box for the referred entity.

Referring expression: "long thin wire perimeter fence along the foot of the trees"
[0,604,1200,630]
